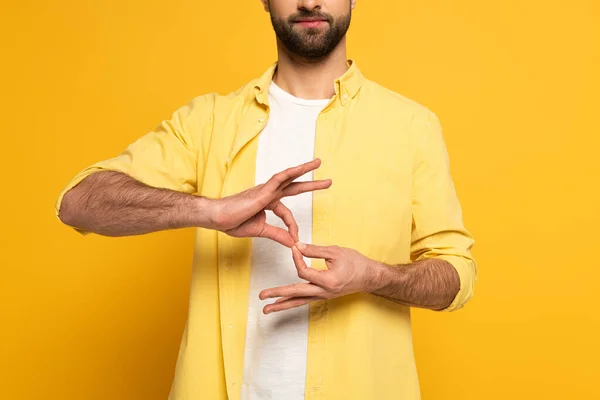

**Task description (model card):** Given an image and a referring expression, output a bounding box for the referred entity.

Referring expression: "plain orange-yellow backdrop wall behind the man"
[0,0,600,400]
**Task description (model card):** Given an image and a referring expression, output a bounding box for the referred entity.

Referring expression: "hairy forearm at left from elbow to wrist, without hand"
[59,171,212,236]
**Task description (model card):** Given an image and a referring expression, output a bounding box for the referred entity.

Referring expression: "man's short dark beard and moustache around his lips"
[271,9,352,59]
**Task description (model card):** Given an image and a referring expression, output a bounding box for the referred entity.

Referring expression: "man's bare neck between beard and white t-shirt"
[273,37,348,100]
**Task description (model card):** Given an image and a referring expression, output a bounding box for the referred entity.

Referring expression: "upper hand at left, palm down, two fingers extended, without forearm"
[208,158,331,248]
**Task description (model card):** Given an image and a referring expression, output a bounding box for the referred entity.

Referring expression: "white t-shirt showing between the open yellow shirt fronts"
[242,83,329,400]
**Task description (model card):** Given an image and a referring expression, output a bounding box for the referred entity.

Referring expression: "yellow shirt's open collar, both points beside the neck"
[254,59,365,105]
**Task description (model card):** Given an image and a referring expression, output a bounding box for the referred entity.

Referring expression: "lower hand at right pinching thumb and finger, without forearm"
[259,242,375,314]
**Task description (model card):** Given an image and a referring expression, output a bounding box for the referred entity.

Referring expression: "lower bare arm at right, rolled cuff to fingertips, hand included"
[259,243,460,314]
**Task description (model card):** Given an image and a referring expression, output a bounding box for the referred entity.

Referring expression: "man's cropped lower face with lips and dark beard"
[262,0,355,59]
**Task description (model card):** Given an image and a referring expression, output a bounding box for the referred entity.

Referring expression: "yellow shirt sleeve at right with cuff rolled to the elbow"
[411,113,477,311]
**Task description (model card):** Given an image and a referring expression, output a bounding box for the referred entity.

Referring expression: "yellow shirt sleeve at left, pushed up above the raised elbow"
[55,95,214,234]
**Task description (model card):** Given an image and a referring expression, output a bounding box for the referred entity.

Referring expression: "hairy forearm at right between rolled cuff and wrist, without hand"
[369,258,460,310]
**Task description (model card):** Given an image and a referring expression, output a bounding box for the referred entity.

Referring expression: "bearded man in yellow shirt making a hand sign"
[57,0,476,400]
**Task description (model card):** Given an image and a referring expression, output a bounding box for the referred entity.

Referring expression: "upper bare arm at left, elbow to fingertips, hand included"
[59,159,331,247]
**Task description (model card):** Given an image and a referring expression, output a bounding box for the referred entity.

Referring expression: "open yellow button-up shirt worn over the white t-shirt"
[56,60,477,400]
